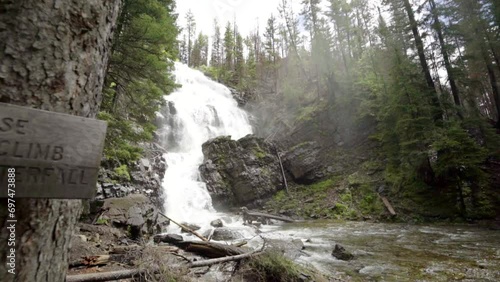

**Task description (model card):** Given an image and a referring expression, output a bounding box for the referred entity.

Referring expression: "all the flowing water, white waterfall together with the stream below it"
[161,63,500,281]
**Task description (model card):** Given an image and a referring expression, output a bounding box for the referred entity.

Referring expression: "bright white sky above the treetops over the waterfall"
[176,0,292,35]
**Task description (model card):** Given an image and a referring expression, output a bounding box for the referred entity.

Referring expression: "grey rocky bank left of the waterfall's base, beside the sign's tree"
[84,142,168,238]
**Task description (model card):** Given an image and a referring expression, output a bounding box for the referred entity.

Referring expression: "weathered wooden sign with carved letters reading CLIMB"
[0,103,107,199]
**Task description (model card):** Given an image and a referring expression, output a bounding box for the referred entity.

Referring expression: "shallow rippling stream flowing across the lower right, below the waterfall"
[263,221,500,281]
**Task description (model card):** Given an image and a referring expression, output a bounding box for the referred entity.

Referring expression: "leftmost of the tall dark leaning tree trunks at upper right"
[403,0,442,121]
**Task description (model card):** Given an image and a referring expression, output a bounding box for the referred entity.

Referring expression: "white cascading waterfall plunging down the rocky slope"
[162,63,252,230]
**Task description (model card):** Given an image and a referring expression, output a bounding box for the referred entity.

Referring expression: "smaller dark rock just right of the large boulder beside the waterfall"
[283,141,325,184]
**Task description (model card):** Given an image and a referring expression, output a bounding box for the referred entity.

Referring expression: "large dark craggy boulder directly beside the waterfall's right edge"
[200,135,282,208]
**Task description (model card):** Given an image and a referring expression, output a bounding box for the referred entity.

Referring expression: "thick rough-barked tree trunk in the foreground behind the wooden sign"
[0,0,121,282]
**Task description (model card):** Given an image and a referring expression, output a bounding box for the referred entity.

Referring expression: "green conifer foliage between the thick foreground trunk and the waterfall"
[98,0,178,166]
